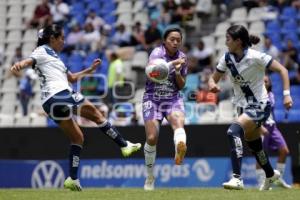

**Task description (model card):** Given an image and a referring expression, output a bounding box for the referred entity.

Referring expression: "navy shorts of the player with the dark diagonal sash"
[238,102,271,127]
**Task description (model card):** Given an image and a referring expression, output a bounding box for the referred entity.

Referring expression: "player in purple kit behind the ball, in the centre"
[143,27,187,190]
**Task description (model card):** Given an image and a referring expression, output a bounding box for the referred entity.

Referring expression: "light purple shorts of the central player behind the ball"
[143,97,184,121]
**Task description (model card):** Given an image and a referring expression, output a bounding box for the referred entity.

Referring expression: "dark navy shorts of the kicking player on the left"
[43,90,84,123]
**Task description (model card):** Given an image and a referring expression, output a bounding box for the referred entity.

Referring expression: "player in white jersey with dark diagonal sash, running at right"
[209,25,293,190]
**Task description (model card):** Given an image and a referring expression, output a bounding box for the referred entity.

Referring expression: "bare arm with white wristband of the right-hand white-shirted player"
[270,60,293,109]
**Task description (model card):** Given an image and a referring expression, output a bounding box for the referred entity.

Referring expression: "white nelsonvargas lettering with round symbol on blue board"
[80,159,215,183]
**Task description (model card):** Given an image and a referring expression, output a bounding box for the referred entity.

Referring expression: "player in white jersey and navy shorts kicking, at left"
[11,25,141,191]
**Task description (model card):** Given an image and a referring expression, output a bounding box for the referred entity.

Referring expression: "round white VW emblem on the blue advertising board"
[31,160,65,188]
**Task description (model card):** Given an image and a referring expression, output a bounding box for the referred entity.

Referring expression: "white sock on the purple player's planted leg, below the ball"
[144,142,156,176]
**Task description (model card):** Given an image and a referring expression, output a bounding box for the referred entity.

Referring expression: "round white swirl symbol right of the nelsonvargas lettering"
[192,159,215,182]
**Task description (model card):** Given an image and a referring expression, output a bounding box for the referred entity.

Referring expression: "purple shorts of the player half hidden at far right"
[263,124,287,151]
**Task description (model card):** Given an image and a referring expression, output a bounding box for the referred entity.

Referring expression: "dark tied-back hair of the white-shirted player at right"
[226,25,260,48]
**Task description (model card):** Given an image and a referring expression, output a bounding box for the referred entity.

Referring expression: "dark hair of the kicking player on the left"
[37,24,63,47]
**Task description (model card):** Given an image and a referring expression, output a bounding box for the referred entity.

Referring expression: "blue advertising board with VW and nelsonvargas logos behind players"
[0,157,292,188]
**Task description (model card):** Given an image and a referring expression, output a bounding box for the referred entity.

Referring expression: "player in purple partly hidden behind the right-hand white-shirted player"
[256,76,291,188]
